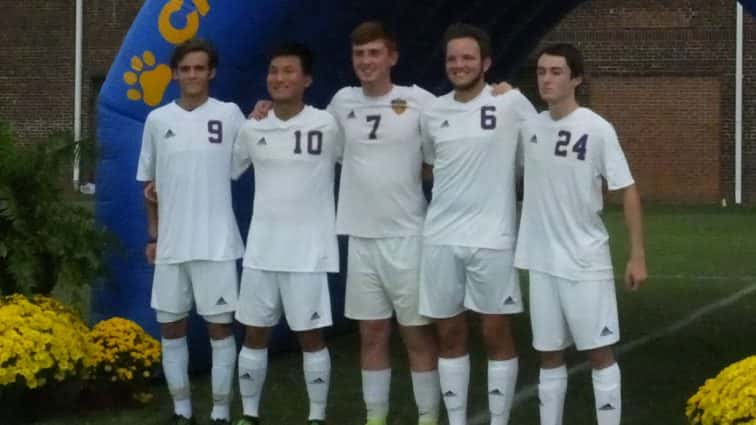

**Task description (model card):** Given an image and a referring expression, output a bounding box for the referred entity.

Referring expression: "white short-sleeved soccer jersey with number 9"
[137,98,245,264]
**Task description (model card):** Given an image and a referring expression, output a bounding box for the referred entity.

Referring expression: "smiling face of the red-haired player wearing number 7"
[352,39,399,85]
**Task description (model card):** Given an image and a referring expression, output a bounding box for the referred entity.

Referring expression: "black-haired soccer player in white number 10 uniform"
[234,43,343,425]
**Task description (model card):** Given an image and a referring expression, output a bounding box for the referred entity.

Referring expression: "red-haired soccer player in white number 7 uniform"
[328,22,441,425]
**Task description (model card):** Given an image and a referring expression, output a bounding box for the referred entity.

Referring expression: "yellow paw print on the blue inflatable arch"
[123,50,172,106]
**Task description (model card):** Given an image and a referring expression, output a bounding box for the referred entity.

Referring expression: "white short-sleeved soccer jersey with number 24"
[515,108,634,281]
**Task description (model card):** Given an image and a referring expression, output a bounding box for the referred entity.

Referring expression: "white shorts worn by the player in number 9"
[150,260,239,323]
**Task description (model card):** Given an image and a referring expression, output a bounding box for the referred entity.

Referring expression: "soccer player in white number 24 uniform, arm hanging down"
[515,44,647,425]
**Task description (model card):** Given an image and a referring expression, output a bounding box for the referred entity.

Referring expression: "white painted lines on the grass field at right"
[468,274,756,425]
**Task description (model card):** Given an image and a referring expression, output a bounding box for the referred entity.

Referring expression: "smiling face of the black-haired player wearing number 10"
[267,55,312,102]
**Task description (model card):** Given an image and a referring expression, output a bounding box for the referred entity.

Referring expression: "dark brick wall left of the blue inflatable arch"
[0,0,142,143]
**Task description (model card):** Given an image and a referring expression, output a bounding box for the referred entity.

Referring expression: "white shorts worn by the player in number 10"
[236,267,333,332]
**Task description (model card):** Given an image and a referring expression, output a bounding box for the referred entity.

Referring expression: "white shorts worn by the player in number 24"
[530,271,620,351]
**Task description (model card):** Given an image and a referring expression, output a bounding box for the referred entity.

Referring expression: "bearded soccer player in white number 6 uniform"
[420,24,535,425]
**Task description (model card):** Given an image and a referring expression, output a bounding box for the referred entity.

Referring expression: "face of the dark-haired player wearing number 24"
[536,53,583,105]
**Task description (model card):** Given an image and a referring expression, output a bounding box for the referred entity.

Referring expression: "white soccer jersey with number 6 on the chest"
[422,88,536,249]
